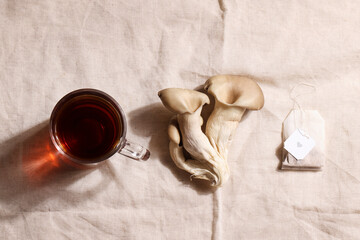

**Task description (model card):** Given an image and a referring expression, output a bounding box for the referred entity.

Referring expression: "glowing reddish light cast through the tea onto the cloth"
[22,124,91,183]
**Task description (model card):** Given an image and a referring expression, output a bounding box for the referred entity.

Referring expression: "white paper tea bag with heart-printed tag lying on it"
[281,110,325,171]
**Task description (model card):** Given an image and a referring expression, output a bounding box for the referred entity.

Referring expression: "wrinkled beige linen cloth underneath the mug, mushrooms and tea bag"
[0,0,360,240]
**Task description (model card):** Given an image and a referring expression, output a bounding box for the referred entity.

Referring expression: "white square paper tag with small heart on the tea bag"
[284,128,315,160]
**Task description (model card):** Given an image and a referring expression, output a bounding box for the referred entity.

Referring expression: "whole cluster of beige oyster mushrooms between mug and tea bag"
[159,75,264,186]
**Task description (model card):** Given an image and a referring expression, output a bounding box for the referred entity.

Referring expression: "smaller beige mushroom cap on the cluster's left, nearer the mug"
[158,88,210,114]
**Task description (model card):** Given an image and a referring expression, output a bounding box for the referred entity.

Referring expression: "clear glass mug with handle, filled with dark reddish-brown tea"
[49,88,150,164]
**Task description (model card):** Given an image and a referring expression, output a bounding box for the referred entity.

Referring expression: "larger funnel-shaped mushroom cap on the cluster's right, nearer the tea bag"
[205,75,264,110]
